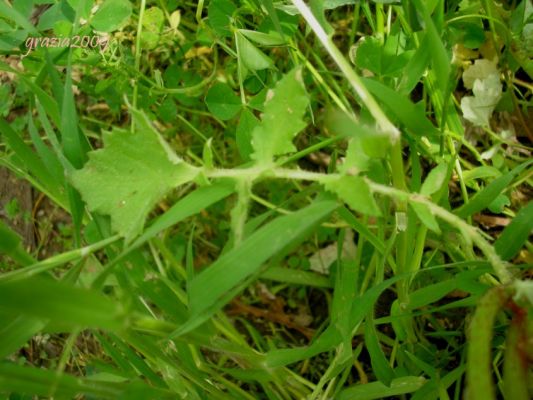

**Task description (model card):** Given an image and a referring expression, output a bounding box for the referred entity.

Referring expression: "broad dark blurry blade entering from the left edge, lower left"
[0,277,127,330]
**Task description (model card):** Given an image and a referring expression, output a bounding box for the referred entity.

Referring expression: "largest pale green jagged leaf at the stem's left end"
[71,110,197,242]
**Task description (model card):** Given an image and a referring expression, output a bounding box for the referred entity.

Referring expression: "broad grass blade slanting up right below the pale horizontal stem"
[176,201,338,334]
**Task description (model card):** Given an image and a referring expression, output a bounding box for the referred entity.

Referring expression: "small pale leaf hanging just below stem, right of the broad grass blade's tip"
[324,175,381,216]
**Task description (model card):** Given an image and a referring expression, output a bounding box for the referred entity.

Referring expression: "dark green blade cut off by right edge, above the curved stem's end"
[494,201,533,260]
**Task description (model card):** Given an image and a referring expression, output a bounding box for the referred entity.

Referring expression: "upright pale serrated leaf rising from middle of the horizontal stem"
[252,68,309,163]
